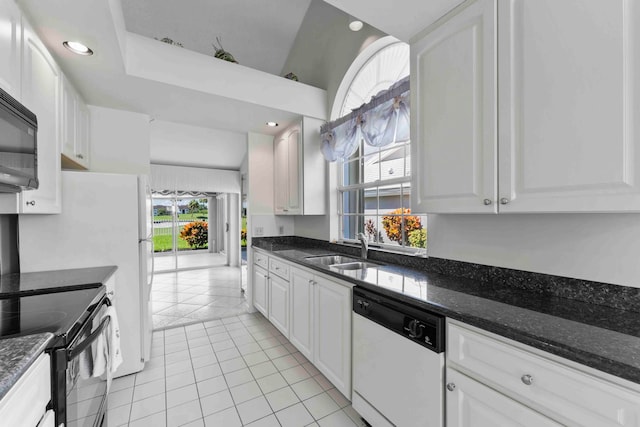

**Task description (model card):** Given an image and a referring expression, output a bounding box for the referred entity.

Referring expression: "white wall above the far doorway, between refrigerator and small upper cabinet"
[150,120,247,170]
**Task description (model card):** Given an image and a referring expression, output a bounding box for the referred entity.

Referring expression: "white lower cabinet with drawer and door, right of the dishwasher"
[446,320,640,427]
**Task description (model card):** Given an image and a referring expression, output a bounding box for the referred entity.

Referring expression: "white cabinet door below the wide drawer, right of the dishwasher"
[445,368,561,427]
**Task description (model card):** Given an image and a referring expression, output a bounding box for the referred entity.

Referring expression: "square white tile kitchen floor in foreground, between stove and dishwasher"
[108,313,365,427]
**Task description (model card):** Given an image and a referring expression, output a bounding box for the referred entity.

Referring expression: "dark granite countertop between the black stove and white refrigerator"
[0,266,118,297]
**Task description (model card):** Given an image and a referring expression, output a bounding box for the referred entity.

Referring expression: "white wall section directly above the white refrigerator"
[89,105,150,175]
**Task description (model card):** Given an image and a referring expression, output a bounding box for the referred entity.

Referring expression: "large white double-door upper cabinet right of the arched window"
[411,0,640,213]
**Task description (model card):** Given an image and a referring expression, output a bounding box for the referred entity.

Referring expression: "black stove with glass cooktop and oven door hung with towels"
[0,270,111,427]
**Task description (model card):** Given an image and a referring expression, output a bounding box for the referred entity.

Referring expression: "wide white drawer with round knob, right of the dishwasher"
[447,323,640,427]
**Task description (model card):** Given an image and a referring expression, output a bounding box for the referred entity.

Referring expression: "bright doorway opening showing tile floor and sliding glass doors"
[150,191,249,330]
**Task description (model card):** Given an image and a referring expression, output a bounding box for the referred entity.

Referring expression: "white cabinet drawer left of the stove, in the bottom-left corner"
[0,353,51,427]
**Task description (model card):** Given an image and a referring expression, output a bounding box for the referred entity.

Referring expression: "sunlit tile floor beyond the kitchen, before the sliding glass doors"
[151,266,250,329]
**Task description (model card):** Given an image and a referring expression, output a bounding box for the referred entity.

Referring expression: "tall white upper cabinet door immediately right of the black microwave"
[20,24,61,213]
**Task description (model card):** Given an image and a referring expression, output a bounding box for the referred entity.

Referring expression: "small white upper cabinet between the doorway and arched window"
[273,117,326,215]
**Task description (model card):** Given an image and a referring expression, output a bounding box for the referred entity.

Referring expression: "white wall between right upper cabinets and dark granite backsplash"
[428,214,640,287]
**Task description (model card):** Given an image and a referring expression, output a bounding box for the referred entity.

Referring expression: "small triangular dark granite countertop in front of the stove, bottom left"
[0,332,53,400]
